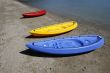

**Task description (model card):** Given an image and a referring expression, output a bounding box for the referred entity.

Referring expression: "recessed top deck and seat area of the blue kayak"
[33,37,100,49]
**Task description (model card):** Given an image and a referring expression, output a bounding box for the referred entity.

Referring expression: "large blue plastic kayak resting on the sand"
[26,35,104,54]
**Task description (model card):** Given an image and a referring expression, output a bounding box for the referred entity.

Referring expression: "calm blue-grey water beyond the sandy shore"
[20,0,110,25]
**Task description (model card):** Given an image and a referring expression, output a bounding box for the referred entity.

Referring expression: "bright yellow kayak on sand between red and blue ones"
[30,21,78,36]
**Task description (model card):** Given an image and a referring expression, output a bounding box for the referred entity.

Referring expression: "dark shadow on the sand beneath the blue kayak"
[20,49,93,58]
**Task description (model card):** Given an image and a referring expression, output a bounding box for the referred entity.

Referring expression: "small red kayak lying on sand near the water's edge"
[23,10,46,17]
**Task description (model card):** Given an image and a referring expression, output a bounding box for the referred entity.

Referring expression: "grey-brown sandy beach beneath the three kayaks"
[0,0,110,73]
